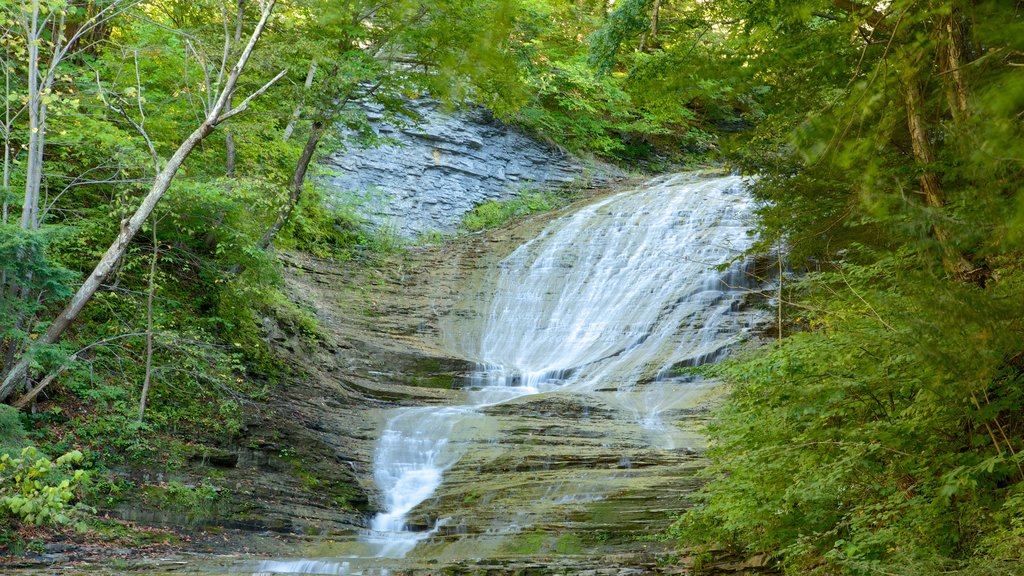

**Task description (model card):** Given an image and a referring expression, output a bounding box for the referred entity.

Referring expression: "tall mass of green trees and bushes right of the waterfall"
[674,0,1024,574]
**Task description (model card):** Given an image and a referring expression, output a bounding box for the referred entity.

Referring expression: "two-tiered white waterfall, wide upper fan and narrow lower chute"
[366,174,753,558]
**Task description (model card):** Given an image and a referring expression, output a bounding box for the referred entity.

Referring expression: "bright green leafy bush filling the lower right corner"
[675,251,1024,574]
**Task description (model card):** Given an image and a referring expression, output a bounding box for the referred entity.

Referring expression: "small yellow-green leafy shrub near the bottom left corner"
[0,446,88,525]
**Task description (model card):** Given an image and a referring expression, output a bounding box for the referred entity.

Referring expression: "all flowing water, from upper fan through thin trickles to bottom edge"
[243,174,760,574]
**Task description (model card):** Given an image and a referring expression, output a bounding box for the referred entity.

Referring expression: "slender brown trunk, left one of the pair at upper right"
[903,66,975,281]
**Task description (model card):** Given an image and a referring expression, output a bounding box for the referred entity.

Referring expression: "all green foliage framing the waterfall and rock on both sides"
[0,0,1024,574]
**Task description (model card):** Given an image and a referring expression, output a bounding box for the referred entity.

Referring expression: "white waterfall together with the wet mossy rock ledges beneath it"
[239,174,764,575]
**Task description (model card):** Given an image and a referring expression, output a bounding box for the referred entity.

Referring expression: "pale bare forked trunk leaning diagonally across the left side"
[0,0,285,402]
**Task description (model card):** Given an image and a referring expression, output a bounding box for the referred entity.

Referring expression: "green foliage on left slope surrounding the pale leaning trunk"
[0,0,540,473]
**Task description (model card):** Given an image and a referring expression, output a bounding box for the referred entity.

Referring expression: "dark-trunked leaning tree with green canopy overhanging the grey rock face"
[245,0,517,250]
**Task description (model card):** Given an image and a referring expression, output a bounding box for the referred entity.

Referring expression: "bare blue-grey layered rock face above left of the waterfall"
[323,98,612,238]
